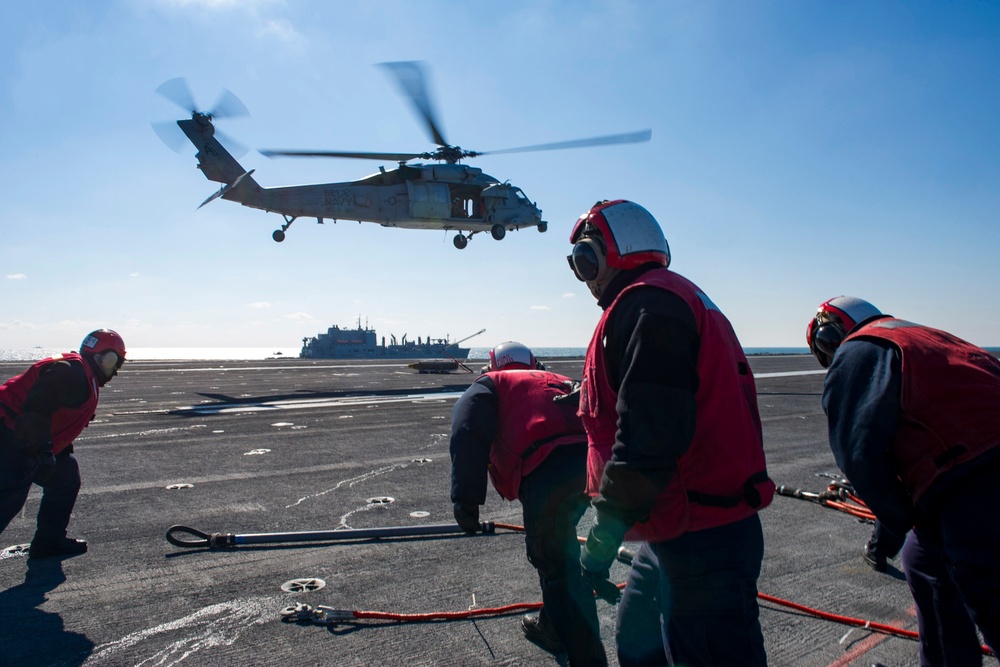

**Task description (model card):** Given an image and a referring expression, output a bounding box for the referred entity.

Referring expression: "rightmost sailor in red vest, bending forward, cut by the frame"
[806,296,1000,665]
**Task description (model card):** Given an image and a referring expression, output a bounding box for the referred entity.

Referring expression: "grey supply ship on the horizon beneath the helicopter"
[299,318,481,359]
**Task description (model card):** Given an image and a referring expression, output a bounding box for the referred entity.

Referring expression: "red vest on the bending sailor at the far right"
[844,318,1000,503]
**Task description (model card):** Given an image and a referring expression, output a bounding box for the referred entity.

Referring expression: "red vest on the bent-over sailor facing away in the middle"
[486,370,587,500]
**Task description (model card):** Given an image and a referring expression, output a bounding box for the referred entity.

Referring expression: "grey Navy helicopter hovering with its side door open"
[153,61,652,250]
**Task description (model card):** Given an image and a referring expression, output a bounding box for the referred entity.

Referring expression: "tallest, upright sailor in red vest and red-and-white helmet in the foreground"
[567,200,774,666]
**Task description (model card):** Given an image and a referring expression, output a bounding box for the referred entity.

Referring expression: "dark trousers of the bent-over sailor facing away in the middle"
[518,444,608,667]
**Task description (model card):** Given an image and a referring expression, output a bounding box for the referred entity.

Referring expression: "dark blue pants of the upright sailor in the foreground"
[616,514,767,667]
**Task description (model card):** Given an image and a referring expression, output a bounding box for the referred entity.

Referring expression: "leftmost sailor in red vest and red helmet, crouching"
[0,329,125,558]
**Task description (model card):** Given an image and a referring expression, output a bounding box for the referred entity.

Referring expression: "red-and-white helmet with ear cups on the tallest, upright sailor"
[566,199,670,299]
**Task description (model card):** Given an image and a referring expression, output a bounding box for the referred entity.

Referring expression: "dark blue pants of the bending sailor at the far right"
[903,464,1000,664]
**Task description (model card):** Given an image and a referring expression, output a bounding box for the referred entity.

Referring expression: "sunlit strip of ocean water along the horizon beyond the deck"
[0,347,809,361]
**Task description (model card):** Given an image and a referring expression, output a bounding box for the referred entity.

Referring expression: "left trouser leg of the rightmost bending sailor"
[902,532,983,667]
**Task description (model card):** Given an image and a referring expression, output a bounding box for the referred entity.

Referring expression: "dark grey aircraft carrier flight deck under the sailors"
[0,355,944,667]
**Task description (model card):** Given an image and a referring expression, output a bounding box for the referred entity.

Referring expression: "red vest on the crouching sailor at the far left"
[0,352,100,454]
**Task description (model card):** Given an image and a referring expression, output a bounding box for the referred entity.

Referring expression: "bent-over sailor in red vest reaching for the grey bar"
[451,341,607,667]
